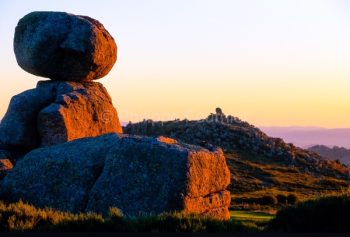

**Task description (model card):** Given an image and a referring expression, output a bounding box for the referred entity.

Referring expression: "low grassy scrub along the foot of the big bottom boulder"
[0,202,254,232]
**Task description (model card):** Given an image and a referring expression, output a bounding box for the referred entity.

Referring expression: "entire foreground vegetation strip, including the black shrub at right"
[0,194,350,232]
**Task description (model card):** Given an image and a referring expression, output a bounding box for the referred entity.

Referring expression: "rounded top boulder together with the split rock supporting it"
[0,12,122,156]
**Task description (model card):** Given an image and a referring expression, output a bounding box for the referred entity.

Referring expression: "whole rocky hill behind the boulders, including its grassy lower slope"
[123,110,349,209]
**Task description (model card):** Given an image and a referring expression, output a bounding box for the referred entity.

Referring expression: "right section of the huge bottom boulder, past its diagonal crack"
[87,134,230,218]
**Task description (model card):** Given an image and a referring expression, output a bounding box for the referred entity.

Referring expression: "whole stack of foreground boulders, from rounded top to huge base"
[0,12,231,219]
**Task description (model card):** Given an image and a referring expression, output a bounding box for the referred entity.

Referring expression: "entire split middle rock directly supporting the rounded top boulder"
[0,81,122,150]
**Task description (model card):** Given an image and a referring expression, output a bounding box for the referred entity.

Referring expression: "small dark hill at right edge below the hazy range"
[308,145,350,165]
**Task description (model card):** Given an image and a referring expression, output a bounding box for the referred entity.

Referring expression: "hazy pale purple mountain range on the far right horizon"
[259,127,350,148]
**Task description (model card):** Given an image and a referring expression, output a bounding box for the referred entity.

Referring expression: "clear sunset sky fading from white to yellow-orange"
[0,0,350,128]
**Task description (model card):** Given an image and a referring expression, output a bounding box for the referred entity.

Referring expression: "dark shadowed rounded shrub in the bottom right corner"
[268,196,350,232]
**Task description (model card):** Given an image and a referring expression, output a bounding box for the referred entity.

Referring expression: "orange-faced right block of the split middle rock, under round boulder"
[37,82,122,146]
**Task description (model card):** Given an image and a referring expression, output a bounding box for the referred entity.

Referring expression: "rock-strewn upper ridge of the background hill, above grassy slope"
[124,109,349,178]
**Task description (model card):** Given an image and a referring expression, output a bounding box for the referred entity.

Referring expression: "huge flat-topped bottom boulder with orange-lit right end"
[0,134,231,219]
